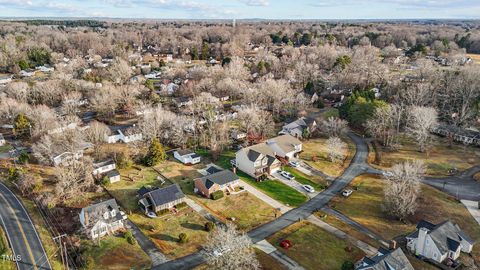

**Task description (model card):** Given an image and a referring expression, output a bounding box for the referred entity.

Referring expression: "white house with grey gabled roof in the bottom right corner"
[406,220,474,263]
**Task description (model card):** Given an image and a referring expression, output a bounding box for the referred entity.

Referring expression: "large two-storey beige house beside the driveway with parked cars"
[235,135,302,178]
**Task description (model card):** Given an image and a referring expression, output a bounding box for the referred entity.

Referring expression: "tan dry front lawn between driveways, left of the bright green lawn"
[191,191,281,231]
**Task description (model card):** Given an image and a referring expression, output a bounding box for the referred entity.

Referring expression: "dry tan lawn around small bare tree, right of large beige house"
[300,138,355,177]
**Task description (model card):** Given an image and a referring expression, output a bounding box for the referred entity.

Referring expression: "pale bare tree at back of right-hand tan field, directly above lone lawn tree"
[407,106,438,152]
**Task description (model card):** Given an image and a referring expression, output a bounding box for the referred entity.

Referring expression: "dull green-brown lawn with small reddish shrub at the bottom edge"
[267,221,365,270]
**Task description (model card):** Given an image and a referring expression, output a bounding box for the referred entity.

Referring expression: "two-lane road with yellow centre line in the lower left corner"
[0,183,52,270]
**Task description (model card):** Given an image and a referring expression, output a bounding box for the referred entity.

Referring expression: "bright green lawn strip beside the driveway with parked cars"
[237,171,308,207]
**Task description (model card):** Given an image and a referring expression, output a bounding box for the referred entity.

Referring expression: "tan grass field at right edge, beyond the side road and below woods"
[369,136,480,176]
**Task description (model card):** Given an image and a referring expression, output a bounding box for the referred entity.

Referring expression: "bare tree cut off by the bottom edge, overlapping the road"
[202,223,260,270]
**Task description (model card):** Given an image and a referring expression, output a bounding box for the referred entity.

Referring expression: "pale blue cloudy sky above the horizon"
[0,0,480,19]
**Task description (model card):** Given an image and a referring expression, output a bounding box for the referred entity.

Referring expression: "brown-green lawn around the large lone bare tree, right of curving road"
[330,175,480,262]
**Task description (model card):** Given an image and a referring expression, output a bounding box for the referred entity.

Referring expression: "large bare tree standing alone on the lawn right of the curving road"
[384,160,425,221]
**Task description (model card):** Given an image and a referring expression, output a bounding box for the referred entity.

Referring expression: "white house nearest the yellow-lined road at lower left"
[79,199,127,239]
